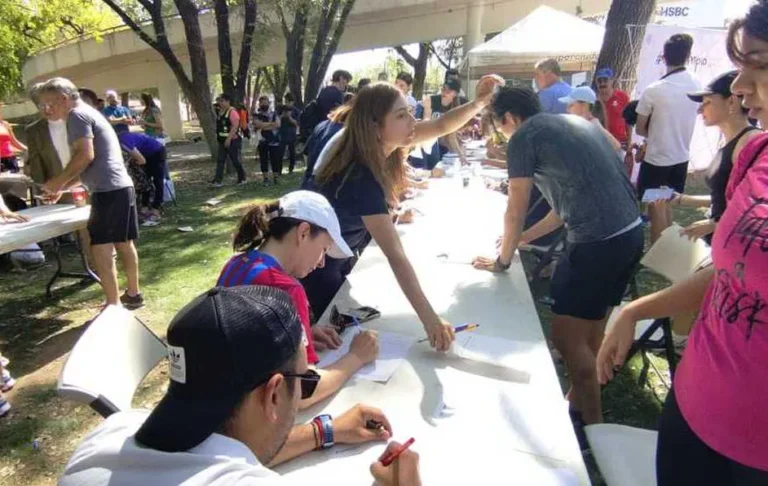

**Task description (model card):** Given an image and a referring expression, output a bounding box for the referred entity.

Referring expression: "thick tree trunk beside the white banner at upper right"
[596,0,656,92]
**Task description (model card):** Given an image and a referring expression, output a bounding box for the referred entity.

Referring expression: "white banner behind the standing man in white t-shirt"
[632,24,735,172]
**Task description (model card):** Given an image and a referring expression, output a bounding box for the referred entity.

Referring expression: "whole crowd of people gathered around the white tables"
[0,0,768,486]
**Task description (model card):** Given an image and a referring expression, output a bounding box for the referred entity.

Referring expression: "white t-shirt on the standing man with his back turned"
[637,71,701,167]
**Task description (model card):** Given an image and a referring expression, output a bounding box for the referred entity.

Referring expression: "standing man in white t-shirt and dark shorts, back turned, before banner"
[636,34,701,242]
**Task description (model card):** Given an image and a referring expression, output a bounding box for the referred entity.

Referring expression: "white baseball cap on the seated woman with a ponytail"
[280,191,355,259]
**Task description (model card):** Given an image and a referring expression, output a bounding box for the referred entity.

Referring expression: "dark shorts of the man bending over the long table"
[550,226,645,321]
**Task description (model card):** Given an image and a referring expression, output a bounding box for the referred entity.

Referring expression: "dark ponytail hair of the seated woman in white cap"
[232,201,325,252]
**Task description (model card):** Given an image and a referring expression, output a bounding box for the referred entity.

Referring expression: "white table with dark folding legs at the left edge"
[0,204,99,297]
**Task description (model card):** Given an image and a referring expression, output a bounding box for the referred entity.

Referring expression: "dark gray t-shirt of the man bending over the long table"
[507,114,640,243]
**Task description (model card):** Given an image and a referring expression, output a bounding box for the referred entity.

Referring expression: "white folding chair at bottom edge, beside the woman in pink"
[584,424,658,486]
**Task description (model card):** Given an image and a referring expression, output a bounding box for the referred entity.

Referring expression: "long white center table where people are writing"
[278,178,590,486]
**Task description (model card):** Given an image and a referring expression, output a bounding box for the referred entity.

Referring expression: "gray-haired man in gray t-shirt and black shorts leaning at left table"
[38,78,144,308]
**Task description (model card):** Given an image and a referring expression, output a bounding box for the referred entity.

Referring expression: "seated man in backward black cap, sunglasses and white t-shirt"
[59,286,420,486]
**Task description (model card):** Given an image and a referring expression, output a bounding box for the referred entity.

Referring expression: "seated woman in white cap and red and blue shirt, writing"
[217,191,378,408]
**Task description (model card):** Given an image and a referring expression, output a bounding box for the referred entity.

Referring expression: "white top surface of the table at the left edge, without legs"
[0,204,91,254]
